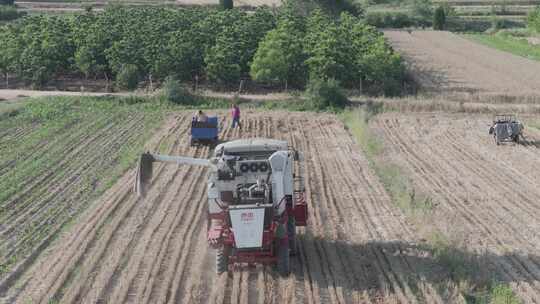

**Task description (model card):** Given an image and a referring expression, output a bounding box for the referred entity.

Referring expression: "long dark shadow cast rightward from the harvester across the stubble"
[278,235,540,303]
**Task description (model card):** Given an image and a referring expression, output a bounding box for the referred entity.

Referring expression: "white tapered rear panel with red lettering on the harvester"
[229,206,265,249]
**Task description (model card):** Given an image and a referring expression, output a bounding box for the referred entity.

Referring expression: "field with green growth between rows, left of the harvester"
[0,97,166,279]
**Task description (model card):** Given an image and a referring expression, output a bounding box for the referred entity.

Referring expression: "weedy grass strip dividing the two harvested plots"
[339,108,521,304]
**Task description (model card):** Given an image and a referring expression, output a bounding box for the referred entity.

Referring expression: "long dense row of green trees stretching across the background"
[0,5,403,94]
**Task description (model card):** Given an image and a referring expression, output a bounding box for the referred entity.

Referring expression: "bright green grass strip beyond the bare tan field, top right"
[464,34,540,61]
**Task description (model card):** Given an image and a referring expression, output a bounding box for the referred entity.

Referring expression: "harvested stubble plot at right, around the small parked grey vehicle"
[372,113,540,303]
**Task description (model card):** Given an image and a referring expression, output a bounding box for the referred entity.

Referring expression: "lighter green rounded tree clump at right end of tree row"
[251,9,403,94]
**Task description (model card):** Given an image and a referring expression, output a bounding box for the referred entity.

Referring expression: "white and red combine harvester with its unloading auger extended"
[135,138,307,275]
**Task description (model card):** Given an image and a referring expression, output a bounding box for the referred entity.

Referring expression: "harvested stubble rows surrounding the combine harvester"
[6,112,460,303]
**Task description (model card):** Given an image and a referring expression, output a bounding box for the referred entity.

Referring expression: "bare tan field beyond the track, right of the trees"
[384,31,540,95]
